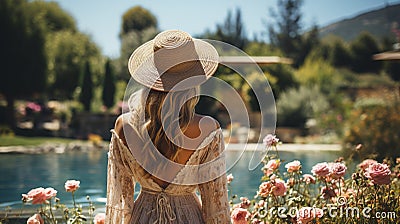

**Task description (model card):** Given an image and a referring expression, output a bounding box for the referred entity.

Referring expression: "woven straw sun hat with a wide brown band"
[128,30,219,92]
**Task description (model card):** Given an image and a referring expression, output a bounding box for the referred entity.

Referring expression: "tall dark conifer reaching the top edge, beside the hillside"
[268,0,305,67]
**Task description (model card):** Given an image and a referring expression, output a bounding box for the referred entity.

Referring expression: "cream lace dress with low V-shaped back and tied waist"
[106,122,230,224]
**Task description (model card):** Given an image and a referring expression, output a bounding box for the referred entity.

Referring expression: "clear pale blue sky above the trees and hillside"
[47,0,400,58]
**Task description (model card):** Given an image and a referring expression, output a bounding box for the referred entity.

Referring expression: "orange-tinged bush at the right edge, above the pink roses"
[343,99,400,159]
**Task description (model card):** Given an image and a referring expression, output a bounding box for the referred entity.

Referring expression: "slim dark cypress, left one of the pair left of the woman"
[79,61,93,111]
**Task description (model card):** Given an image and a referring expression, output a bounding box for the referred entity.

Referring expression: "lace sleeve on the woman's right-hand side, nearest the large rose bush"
[199,132,230,224]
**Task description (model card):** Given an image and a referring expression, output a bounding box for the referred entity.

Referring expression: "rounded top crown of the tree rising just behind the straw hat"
[121,6,157,35]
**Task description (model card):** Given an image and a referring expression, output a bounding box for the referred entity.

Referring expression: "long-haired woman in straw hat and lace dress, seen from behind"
[106,30,230,224]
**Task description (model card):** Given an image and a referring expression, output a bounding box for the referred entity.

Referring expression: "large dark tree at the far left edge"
[0,0,47,128]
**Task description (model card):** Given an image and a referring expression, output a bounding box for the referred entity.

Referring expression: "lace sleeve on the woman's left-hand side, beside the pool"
[105,132,135,224]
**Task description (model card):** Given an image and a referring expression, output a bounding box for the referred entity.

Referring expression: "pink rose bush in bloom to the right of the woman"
[229,135,400,224]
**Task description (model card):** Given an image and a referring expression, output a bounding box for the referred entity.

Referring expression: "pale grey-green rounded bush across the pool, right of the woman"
[276,85,329,128]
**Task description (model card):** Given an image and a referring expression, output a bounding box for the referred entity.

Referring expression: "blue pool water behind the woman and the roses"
[0,150,339,209]
